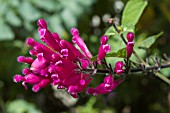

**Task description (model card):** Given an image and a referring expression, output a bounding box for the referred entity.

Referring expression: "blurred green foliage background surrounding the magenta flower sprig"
[0,0,170,113]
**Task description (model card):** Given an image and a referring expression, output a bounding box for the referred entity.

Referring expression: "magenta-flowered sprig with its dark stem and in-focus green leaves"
[13,0,170,98]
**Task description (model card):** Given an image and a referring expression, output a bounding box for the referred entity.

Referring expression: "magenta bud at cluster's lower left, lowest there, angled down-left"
[32,78,51,92]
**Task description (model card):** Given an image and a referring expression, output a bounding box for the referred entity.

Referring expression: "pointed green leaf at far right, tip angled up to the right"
[139,32,163,48]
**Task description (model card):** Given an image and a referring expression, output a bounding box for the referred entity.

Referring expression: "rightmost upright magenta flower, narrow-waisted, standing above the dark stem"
[126,32,135,58]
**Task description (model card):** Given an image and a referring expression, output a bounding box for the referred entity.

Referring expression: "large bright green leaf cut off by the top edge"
[121,0,148,26]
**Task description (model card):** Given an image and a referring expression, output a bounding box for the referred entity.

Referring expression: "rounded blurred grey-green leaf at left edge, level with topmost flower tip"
[0,23,14,41]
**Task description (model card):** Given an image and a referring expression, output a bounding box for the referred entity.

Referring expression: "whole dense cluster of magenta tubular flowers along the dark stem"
[13,19,123,98]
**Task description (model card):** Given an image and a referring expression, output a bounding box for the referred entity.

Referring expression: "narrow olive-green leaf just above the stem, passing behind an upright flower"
[91,48,126,61]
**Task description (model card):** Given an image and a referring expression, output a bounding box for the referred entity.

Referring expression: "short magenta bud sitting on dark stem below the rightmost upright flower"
[114,61,124,75]
